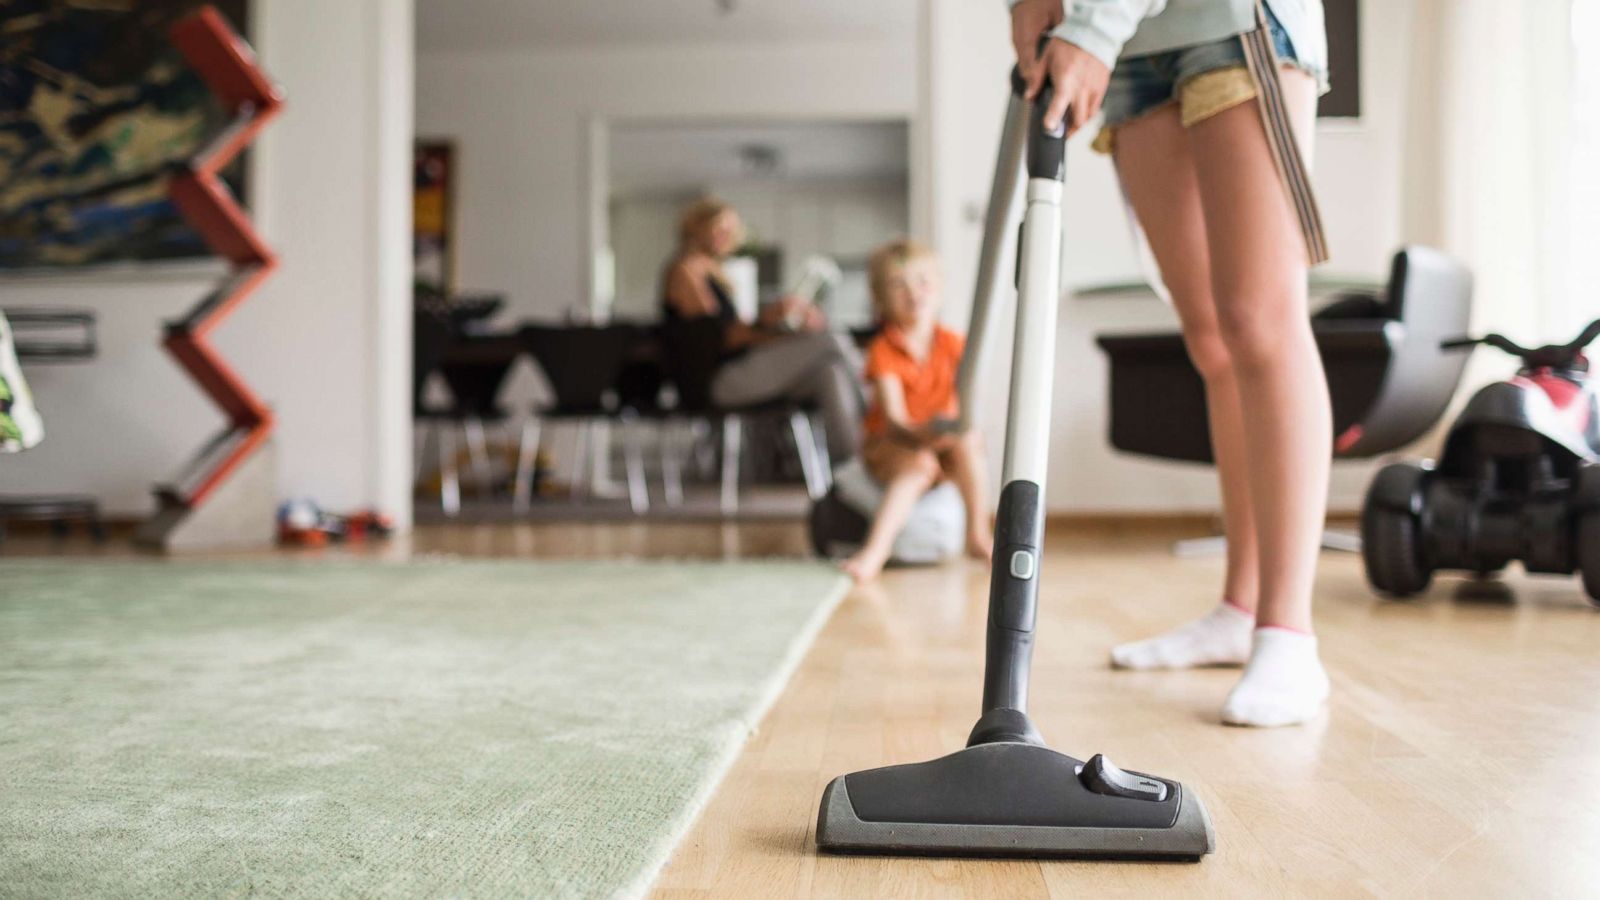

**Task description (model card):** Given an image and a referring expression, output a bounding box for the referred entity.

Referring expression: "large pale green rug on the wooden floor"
[0,560,845,897]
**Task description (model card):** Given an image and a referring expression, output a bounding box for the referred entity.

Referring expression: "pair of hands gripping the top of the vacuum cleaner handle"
[1011,0,1110,135]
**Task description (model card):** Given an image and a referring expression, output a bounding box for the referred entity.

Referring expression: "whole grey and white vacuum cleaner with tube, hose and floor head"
[816,70,1216,860]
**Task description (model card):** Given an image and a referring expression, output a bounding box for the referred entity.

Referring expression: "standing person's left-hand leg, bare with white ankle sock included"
[1110,106,1258,669]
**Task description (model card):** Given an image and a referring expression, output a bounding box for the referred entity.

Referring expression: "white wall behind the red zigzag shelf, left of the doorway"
[0,0,411,522]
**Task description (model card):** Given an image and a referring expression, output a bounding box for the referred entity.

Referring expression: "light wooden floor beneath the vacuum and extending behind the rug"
[6,524,1600,900]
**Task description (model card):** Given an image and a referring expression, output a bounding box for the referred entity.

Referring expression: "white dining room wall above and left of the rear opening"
[416,35,917,325]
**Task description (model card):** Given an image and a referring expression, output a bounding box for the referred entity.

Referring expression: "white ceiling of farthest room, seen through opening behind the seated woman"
[611,122,907,194]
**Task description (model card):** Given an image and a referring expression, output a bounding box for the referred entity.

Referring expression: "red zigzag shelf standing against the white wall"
[157,6,283,508]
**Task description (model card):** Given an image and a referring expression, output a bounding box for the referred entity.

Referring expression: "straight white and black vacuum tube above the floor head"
[968,74,1066,733]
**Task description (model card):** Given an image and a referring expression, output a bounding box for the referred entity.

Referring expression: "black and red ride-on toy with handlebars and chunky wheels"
[1362,320,1600,604]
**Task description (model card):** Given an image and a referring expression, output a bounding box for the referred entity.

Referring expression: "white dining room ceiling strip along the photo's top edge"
[416,0,915,53]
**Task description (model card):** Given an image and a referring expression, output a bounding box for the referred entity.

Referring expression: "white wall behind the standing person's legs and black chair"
[912,0,1413,512]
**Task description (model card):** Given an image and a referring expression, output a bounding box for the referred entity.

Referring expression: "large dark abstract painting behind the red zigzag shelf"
[0,0,250,272]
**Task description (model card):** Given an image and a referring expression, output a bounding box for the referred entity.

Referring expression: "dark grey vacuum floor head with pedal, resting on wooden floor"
[816,741,1216,862]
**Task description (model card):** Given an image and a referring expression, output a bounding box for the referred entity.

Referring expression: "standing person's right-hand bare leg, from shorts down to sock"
[1189,72,1333,633]
